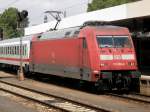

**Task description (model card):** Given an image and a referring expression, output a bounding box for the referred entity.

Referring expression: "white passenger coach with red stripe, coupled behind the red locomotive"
[0,36,32,68]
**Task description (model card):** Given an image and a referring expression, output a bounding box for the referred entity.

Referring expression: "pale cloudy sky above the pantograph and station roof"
[0,0,91,26]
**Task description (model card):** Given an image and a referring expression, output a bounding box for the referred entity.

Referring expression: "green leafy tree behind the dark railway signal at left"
[0,7,29,39]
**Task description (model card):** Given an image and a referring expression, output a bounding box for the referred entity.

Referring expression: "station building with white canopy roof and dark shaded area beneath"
[25,0,150,71]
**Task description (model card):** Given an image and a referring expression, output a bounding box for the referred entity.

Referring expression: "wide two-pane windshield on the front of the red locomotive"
[97,36,132,48]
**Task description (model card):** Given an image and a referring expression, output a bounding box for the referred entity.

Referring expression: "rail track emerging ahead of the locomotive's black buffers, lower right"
[107,93,150,104]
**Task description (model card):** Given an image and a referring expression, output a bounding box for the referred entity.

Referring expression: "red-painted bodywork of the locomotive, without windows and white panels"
[30,27,137,81]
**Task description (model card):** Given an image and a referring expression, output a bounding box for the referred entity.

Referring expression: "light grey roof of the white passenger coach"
[0,36,32,44]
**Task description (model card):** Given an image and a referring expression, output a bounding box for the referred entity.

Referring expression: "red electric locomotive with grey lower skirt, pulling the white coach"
[29,21,140,92]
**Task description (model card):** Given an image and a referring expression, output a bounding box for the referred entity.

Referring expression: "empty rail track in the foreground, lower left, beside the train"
[0,80,111,112]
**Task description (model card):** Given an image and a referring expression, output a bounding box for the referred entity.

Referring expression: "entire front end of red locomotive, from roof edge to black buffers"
[83,25,141,92]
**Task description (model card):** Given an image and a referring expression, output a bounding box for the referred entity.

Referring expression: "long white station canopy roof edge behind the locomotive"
[25,0,150,35]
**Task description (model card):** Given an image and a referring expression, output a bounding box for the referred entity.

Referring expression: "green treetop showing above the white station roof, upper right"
[87,0,139,12]
